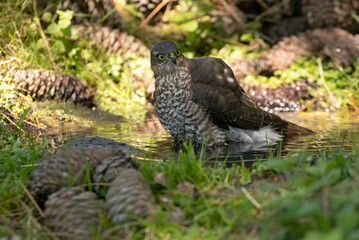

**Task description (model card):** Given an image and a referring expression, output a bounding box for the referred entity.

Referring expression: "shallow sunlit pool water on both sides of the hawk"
[38,105,359,162]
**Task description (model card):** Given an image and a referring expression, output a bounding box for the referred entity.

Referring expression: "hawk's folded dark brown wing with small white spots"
[190,57,288,130]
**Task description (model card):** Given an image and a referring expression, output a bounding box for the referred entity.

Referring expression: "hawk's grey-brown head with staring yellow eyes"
[151,41,184,75]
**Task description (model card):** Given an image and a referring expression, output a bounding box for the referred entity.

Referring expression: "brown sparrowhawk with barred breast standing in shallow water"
[151,41,311,146]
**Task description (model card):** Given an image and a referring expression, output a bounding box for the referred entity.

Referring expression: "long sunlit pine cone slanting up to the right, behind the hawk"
[256,28,353,75]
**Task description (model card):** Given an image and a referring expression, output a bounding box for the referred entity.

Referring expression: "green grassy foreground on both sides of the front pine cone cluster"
[0,132,359,239]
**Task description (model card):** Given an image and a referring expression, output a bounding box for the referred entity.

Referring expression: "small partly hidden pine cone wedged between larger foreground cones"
[93,156,138,182]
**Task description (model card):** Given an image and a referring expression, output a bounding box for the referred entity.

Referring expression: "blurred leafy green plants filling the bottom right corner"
[253,151,359,239]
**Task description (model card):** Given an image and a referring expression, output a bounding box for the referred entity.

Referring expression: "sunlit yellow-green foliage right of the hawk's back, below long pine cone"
[244,57,359,108]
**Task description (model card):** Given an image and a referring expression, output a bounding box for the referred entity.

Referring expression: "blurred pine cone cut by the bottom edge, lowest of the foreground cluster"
[45,187,104,239]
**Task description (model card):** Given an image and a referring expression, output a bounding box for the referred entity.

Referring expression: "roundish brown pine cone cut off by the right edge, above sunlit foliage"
[321,38,359,68]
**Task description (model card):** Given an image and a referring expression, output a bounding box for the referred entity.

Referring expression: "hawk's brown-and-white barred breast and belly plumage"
[154,65,226,145]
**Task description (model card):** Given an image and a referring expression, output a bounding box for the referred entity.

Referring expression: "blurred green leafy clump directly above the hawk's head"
[125,0,243,56]
